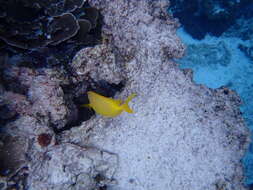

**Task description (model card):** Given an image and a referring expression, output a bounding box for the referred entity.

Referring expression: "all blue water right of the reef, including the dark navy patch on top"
[169,0,253,186]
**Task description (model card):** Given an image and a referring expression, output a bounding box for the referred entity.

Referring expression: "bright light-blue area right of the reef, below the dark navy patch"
[177,24,253,185]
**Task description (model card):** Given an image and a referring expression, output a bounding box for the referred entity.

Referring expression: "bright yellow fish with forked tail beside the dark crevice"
[83,91,136,117]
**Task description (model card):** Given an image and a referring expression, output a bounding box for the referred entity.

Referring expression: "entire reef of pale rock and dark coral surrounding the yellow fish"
[0,0,248,190]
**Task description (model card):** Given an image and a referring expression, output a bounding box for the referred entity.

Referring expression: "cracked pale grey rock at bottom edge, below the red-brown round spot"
[28,143,118,190]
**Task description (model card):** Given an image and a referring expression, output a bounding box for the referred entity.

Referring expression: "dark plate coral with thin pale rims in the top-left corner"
[0,0,101,66]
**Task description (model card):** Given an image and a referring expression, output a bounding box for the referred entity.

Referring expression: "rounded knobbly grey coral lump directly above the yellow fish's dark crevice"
[70,45,123,84]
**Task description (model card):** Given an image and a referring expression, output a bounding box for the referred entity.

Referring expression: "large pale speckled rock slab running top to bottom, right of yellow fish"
[60,0,249,190]
